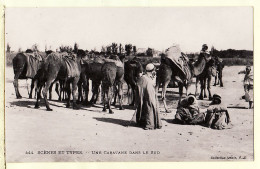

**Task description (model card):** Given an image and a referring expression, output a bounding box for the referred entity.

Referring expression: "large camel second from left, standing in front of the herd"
[35,52,81,111]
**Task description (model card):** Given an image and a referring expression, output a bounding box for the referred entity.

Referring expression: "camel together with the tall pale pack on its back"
[156,45,214,112]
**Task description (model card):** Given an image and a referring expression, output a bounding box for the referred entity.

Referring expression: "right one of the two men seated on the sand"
[205,94,232,130]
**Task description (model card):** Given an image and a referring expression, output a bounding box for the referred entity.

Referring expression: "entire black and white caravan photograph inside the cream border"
[4,6,255,163]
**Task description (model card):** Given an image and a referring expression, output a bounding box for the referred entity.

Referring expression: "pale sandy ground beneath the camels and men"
[5,66,253,162]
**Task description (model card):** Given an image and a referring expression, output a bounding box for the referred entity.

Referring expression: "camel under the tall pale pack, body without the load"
[156,51,207,113]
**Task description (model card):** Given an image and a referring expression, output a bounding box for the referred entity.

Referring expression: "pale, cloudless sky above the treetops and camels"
[5,7,253,52]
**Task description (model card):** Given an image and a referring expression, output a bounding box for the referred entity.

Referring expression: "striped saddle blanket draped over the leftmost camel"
[23,53,43,78]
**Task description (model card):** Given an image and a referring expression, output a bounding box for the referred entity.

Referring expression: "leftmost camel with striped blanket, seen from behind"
[13,50,44,99]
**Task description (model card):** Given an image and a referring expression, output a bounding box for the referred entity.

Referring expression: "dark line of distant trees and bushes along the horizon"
[6,43,253,66]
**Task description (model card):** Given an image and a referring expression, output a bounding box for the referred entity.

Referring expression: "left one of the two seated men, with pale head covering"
[175,94,205,124]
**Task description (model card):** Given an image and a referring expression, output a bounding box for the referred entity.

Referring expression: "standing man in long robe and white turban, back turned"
[134,63,162,130]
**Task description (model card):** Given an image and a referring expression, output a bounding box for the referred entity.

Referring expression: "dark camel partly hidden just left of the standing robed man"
[124,58,144,106]
